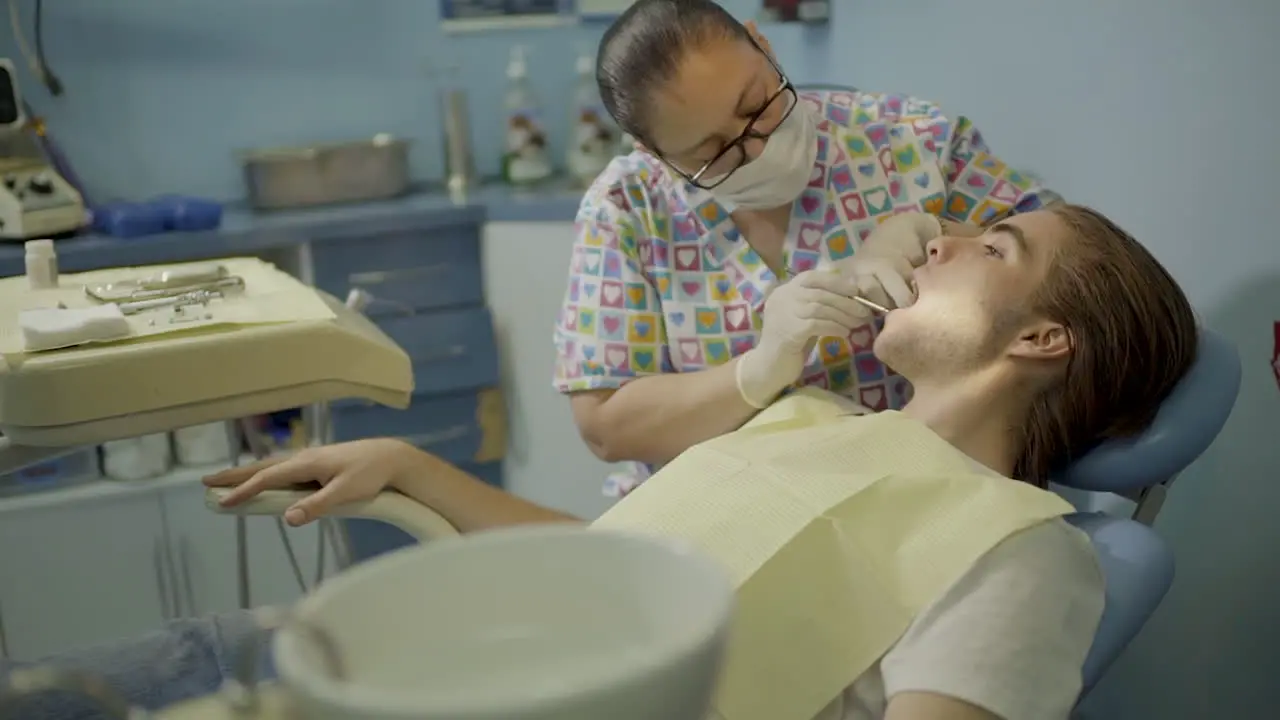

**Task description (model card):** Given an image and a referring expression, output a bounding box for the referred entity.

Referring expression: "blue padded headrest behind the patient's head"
[1053,328,1240,493]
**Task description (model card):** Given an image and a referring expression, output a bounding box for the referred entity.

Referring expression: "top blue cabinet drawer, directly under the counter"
[312,225,484,315]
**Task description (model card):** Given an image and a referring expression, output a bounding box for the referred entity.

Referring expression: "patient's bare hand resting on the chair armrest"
[205,438,439,525]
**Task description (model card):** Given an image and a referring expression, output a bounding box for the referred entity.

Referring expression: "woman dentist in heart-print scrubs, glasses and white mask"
[554,0,1056,496]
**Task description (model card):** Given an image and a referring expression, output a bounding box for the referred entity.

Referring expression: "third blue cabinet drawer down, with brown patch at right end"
[332,388,507,464]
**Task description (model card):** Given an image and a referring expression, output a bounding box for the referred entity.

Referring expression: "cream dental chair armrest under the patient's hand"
[205,488,458,542]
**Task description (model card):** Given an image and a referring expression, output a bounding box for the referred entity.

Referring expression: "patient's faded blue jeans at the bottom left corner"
[0,611,274,720]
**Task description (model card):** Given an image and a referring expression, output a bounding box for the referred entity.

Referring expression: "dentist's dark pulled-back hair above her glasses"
[595,0,751,145]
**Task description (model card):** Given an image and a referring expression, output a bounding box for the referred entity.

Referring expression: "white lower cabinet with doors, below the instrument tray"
[0,469,335,660]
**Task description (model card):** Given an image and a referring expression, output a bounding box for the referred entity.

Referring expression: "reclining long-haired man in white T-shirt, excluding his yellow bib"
[2,206,1197,720]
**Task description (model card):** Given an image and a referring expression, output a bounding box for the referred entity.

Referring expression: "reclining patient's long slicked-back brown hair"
[1014,205,1198,487]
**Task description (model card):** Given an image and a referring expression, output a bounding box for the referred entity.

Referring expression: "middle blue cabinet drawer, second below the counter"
[374,306,499,395]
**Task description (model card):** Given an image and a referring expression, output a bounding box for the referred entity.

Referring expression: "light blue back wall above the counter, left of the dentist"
[0,0,820,200]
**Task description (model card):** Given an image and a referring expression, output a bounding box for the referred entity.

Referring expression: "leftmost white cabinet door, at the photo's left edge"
[0,493,165,660]
